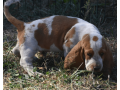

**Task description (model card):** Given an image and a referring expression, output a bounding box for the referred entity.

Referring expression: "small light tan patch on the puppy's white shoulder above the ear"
[65,27,75,47]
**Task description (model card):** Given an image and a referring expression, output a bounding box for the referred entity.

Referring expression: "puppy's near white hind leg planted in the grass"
[20,46,43,76]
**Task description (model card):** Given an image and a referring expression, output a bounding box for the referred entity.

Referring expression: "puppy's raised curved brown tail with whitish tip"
[4,0,24,31]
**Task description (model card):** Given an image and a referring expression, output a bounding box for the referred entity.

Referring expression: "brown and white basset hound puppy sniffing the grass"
[4,0,113,76]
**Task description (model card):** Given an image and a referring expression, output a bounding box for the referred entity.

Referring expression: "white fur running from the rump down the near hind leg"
[20,20,40,76]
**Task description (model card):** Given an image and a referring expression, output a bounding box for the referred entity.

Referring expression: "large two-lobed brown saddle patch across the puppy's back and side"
[35,16,78,50]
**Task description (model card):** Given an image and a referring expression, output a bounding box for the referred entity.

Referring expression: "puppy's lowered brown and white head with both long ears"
[64,34,113,75]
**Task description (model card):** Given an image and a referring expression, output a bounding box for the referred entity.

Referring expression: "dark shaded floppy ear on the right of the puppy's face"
[102,38,114,77]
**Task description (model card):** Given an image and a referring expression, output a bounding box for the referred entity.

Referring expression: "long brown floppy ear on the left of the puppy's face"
[64,41,85,69]
